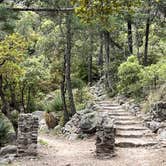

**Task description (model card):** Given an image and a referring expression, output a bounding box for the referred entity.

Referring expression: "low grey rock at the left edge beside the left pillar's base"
[0,145,17,156]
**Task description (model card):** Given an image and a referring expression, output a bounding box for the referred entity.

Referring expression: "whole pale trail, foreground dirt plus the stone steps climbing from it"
[13,100,166,166]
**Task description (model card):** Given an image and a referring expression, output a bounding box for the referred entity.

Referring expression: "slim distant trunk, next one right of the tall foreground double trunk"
[88,32,93,86]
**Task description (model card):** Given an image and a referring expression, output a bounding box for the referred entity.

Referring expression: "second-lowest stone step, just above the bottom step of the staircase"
[116,130,153,138]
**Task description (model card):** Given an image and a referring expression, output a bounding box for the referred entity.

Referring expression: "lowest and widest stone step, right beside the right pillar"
[115,138,157,148]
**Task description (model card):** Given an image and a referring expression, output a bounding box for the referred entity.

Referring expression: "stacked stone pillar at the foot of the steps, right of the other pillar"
[96,113,116,159]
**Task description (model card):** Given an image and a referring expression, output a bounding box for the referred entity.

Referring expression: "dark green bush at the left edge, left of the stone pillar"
[0,113,10,147]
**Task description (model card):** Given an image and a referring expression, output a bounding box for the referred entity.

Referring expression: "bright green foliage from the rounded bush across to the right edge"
[118,56,166,96]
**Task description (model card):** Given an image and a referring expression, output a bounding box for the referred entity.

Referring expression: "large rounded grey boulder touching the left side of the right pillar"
[79,112,97,134]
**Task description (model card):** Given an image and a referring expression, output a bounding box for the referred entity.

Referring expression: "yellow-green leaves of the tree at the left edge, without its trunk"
[0,34,28,80]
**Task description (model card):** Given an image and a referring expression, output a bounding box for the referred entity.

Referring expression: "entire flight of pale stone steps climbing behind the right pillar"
[98,101,158,148]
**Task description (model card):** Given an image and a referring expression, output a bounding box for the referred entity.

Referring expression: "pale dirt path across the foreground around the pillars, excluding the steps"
[13,136,166,166]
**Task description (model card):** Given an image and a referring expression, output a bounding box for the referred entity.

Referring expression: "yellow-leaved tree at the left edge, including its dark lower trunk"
[0,34,27,131]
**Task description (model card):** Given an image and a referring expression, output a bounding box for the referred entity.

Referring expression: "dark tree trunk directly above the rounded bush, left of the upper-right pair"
[127,15,133,55]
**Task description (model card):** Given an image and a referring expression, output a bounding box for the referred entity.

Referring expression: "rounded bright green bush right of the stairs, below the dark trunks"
[118,56,142,96]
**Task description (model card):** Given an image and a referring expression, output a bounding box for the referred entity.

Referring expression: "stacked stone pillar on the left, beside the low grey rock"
[17,114,39,157]
